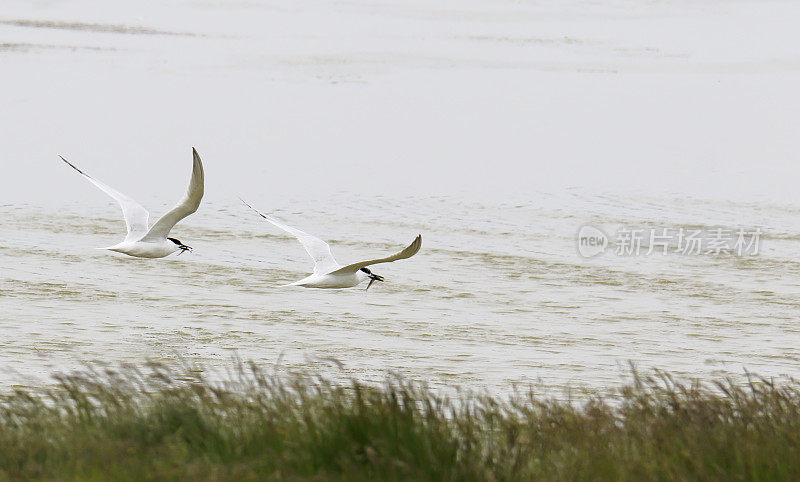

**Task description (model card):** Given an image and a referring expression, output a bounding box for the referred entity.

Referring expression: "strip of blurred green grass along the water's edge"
[0,364,800,481]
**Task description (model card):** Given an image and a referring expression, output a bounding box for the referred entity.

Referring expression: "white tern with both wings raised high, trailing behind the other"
[59,148,204,258]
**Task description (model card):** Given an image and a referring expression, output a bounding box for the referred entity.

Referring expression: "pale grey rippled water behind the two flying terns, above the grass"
[0,0,800,390]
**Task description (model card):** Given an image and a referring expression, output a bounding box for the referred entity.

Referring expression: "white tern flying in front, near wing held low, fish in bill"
[242,201,422,289]
